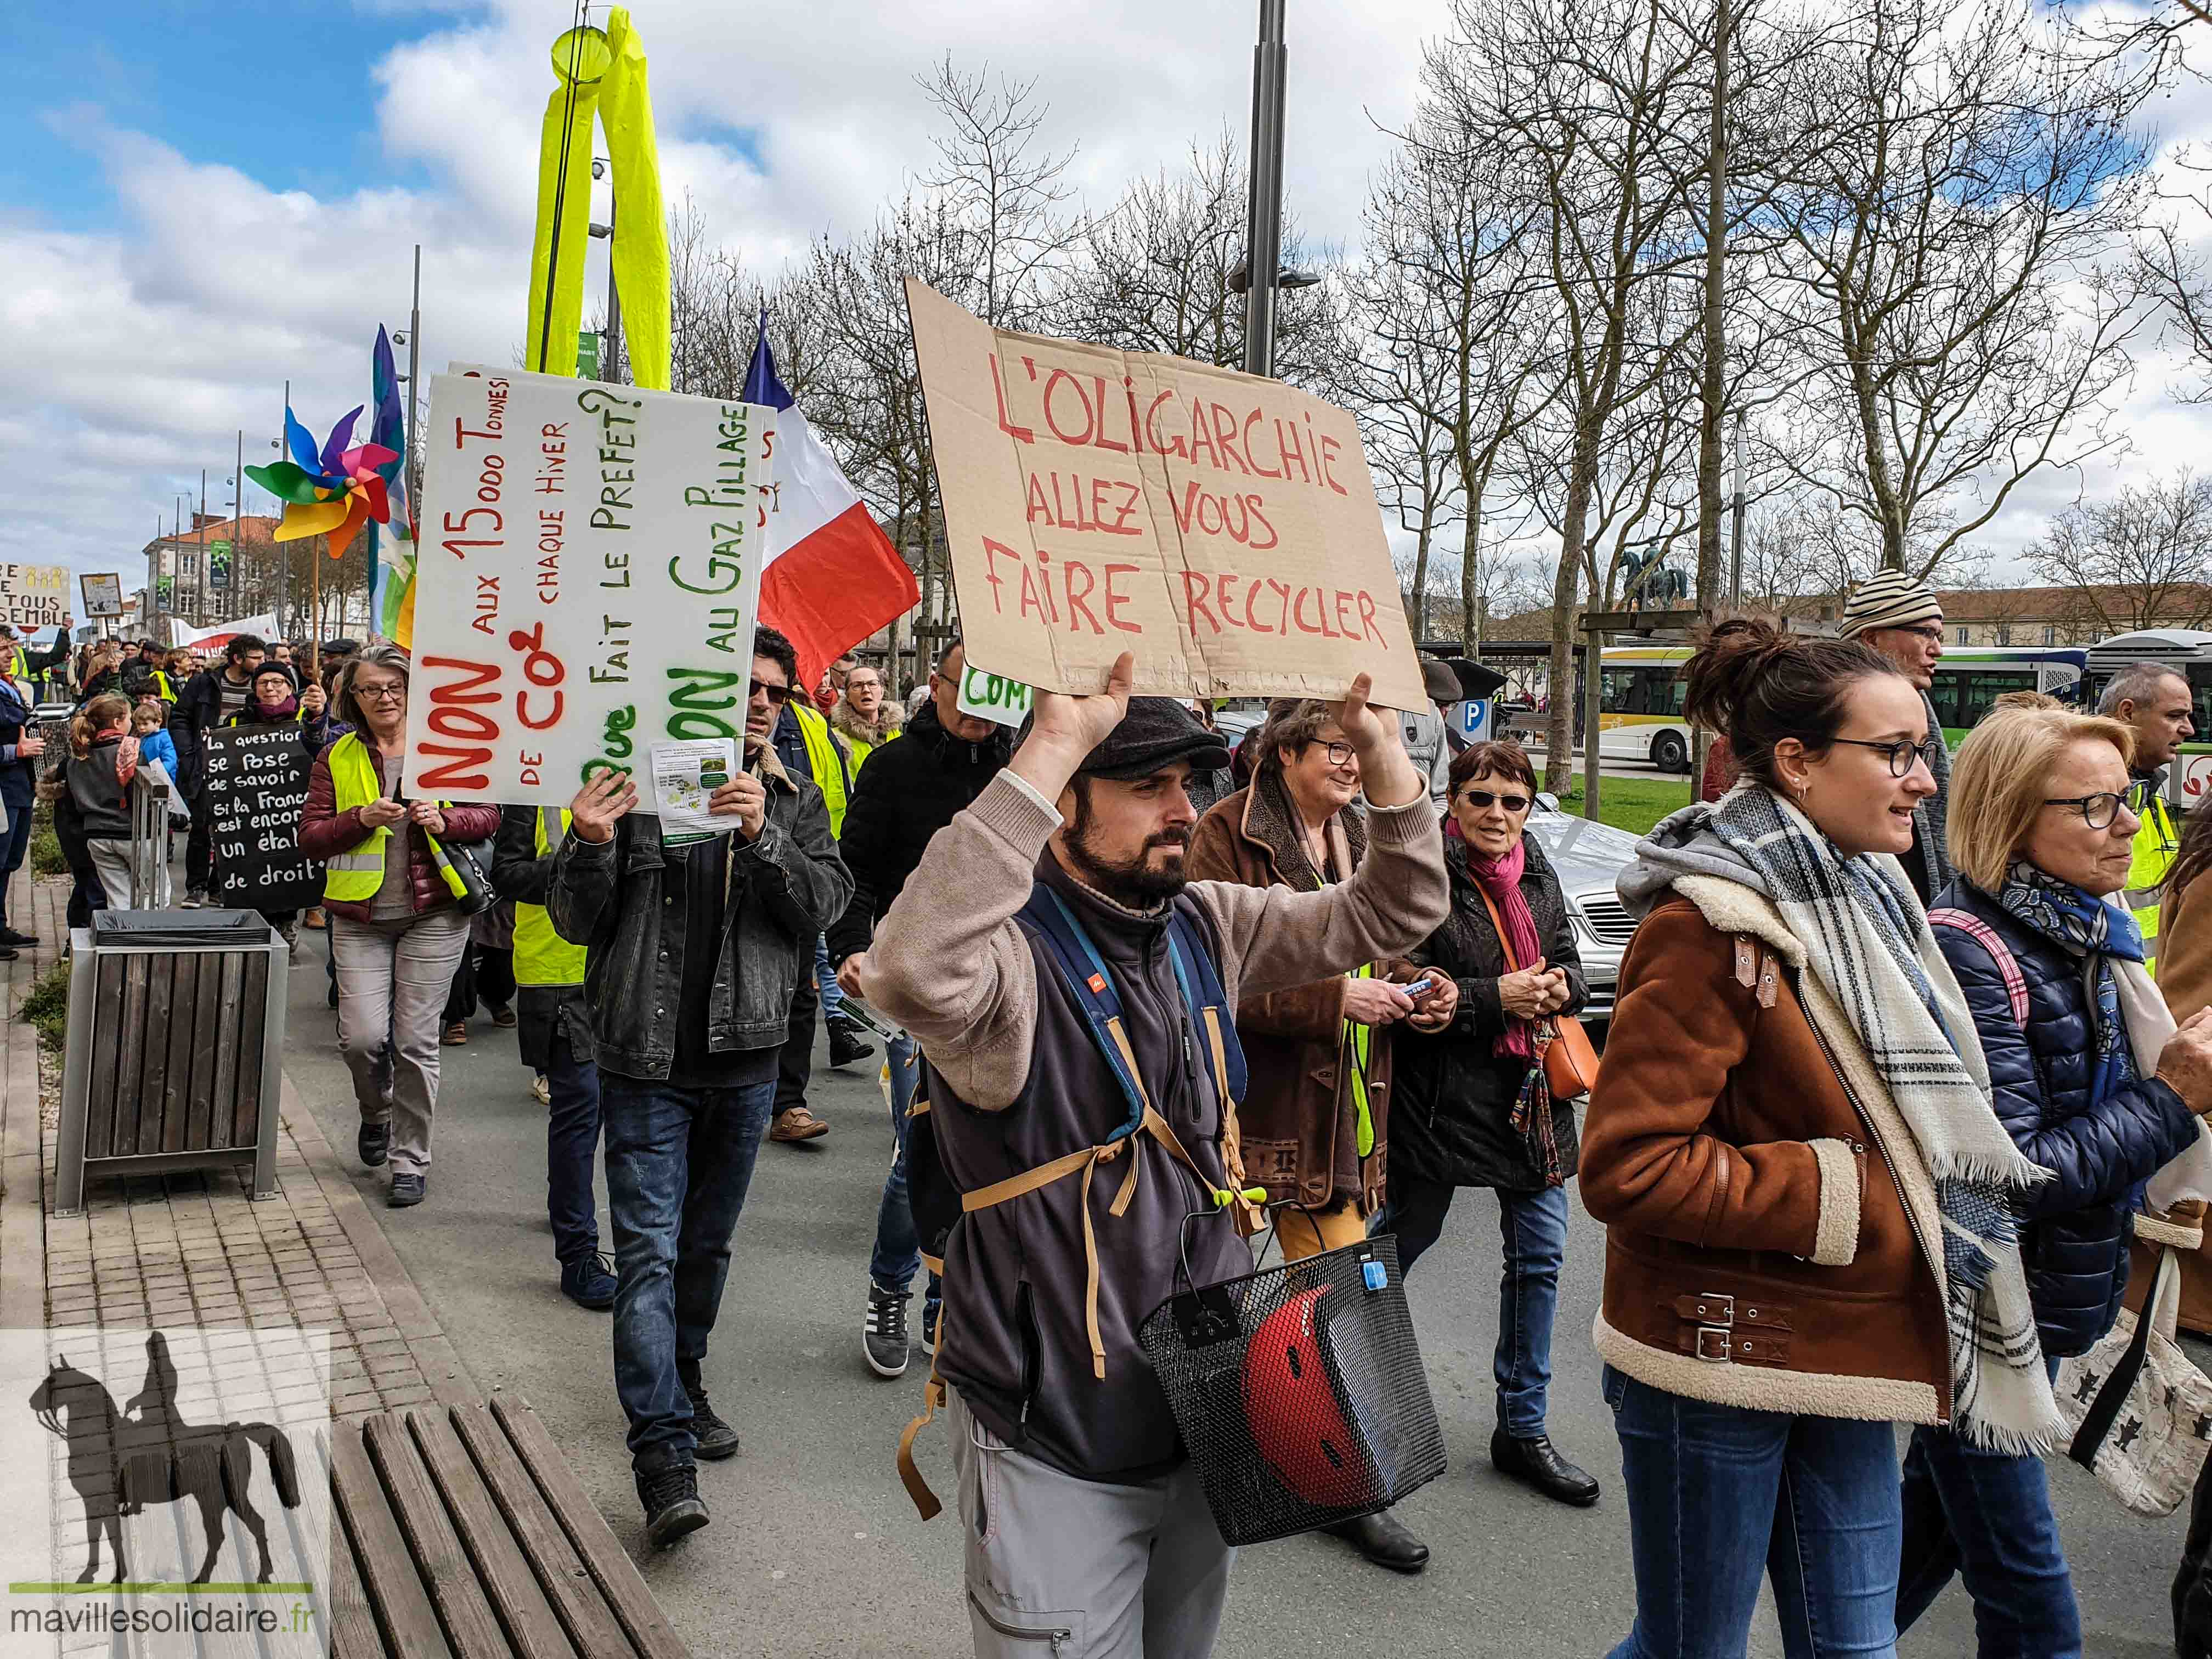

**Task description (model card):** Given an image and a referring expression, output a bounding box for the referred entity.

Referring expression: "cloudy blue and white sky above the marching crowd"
[0,0,2212,619]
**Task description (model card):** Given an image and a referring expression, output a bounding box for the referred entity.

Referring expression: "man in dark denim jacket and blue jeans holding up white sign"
[546,628,851,1546]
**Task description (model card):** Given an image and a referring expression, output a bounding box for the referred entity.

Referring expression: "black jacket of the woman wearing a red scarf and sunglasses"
[1389,836,1590,1192]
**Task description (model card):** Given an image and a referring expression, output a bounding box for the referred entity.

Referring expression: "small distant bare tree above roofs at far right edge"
[2028,467,2212,635]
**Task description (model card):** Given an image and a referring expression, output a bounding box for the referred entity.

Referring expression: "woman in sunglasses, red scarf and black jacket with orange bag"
[1383,743,1597,1506]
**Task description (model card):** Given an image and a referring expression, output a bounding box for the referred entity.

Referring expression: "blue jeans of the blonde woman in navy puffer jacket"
[1898,1361,2081,1659]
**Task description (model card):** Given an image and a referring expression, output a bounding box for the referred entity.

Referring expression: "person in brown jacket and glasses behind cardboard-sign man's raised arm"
[1183,697,1460,1573]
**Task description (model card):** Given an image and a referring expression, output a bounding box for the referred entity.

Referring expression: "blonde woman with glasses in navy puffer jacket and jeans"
[1898,692,2212,1659]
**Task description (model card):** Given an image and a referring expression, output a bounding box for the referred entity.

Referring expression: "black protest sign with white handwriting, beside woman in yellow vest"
[199,721,323,909]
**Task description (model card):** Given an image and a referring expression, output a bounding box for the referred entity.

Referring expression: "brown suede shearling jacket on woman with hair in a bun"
[1582,878,1951,1423]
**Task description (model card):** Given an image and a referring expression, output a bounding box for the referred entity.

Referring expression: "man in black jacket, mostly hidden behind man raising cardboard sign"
[832,639,1013,1376]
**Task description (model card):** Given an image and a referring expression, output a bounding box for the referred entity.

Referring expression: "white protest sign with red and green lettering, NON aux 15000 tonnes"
[405,369,776,812]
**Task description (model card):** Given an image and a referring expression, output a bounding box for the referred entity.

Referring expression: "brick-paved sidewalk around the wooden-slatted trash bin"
[0,872,482,1418]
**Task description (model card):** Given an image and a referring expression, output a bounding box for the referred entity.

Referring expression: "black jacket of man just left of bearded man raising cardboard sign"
[830,703,1013,960]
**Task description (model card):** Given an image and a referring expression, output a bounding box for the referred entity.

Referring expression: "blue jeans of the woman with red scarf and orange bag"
[1376,1179,1566,1440]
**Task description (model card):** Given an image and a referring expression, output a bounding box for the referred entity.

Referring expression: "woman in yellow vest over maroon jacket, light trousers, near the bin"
[298,644,500,1207]
